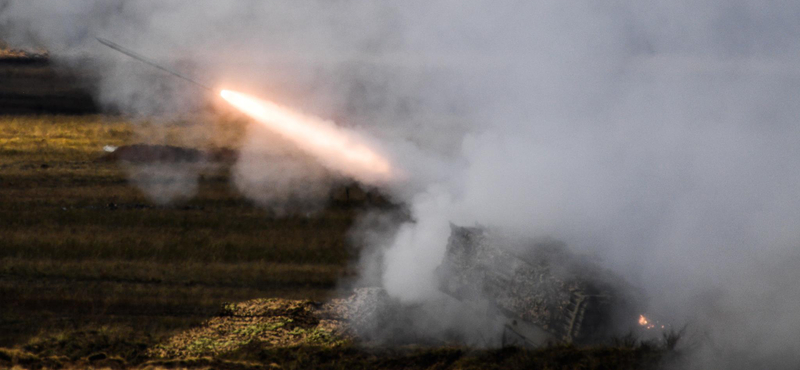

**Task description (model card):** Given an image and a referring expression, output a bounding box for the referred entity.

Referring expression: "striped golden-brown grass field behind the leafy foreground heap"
[0,116,357,354]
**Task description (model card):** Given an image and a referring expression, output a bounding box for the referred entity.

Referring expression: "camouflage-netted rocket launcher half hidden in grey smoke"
[437,226,642,342]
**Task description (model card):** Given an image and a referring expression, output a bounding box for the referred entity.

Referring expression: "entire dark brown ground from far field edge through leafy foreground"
[0,53,674,369]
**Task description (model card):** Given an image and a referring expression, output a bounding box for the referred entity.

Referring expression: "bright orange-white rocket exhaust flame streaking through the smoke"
[220,90,396,185]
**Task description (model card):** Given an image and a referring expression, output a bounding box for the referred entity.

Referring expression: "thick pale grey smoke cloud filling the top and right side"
[0,0,800,368]
